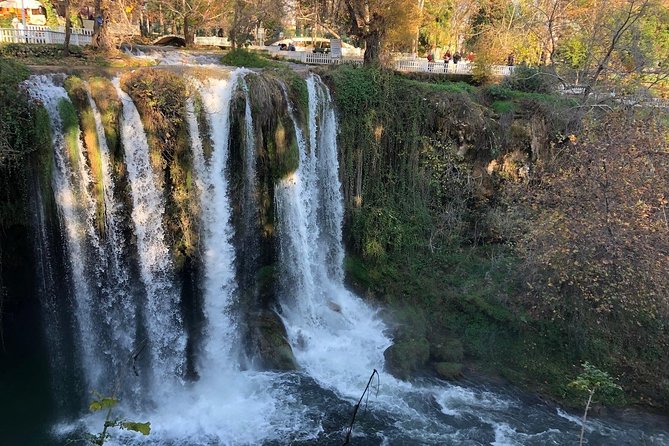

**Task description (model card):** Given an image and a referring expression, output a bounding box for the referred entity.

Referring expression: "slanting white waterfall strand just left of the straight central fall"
[114,78,186,392]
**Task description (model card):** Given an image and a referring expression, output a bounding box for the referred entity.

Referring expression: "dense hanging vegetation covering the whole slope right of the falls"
[323,63,669,412]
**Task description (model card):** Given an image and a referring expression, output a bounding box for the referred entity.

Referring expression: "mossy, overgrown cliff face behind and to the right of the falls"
[0,61,669,412]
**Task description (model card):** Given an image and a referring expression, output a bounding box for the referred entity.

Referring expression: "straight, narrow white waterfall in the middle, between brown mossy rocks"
[188,72,238,374]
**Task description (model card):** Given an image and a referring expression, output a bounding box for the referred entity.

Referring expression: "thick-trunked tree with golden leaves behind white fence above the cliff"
[345,0,420,65]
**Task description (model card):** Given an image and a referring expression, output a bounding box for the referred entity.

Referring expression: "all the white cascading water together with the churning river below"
[20,69,669,445]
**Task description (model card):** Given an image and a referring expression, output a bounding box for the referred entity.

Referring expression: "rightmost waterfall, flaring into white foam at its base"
[276,75,391,397]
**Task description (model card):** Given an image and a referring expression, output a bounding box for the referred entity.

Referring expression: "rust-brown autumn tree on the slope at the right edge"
[513,109,669,372]
